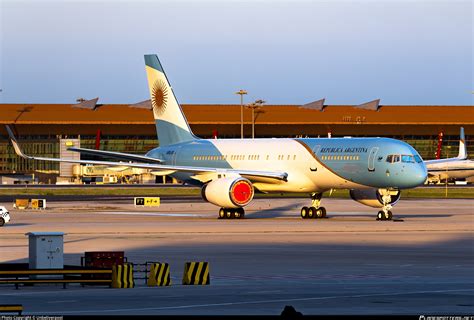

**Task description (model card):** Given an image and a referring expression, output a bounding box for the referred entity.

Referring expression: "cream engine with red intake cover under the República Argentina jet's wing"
[201,177,254,208]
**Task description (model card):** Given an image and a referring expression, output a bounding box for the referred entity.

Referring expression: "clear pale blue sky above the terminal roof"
[0,0,474,105]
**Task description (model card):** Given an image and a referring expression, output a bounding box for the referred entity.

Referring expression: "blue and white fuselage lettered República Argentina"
[147,138,426,192]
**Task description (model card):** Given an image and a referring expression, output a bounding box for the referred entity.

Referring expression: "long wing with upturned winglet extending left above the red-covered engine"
[6,126,288,181]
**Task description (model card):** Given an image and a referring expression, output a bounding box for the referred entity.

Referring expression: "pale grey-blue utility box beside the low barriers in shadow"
[25,232,64,269]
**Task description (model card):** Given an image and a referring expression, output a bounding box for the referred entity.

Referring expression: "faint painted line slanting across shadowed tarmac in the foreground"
[25,289,474,315]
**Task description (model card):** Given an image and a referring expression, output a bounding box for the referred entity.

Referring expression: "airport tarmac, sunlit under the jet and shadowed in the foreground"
[0,198,474,316]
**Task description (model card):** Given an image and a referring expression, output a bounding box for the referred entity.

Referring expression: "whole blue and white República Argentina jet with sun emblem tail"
[7,55,427,220]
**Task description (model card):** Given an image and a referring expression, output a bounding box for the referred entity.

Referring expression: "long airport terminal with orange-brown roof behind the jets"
[0,100,474,182]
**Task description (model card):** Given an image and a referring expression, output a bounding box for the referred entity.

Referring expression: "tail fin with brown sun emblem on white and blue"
[145,54,196,146]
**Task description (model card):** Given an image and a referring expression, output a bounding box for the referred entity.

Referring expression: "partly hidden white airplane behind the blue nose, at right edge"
[425,127,474,183]
